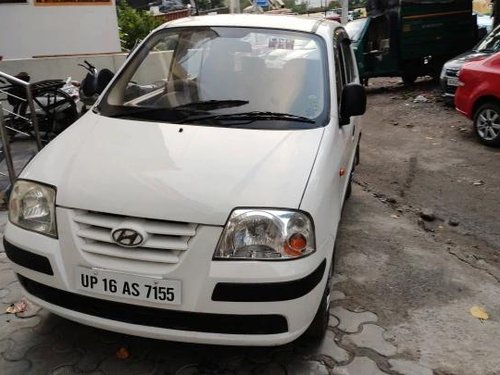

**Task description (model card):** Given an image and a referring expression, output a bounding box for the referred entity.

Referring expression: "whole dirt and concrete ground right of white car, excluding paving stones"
[336,79,500,375]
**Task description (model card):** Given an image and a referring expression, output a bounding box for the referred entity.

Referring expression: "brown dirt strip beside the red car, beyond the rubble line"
[358,79,500,251]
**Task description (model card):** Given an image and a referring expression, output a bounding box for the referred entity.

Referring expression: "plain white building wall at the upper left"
[0,0,120,60]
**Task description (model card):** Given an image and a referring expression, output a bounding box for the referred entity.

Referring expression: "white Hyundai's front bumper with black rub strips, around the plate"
[5,209,329,346]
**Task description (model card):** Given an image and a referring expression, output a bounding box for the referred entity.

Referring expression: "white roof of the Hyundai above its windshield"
[161,14,340,32]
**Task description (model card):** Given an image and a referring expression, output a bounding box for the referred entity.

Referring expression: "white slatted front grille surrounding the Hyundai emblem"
[73,210,197,264]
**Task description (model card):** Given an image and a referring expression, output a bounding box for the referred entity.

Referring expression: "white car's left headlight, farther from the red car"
[9,180,57,237]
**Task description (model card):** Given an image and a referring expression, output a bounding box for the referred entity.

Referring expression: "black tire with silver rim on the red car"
[473,101,500,147]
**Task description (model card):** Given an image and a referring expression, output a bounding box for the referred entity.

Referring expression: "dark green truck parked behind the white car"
[346,0,477,84]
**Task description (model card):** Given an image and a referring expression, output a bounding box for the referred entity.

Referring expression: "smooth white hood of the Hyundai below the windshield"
[21,113,323,225]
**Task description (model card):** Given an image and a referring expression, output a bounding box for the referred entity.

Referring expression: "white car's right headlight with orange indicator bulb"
[214,209,316,260]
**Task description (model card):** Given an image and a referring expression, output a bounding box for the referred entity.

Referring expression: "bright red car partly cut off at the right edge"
[455,53,500,146]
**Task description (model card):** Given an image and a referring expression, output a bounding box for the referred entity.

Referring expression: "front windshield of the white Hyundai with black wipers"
[98,27,329,128]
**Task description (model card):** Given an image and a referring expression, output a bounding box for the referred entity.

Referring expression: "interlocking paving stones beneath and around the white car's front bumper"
[0,213,432,375]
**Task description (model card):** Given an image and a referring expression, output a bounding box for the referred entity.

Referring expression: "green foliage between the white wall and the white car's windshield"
[116,0,163,51]
